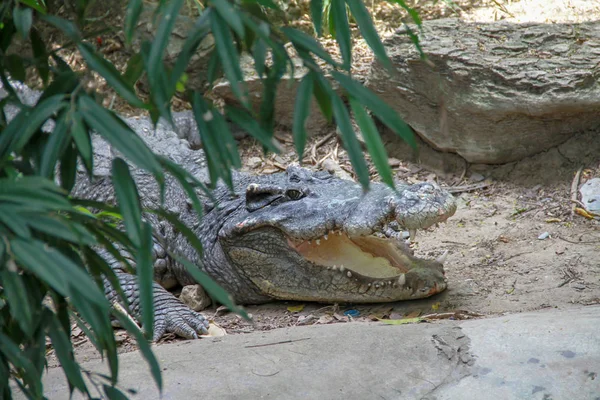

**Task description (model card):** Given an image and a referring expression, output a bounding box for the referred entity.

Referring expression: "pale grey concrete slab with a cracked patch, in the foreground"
[19,306,600,400]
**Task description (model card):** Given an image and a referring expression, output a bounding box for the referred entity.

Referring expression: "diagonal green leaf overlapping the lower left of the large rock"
[331,71,417,149]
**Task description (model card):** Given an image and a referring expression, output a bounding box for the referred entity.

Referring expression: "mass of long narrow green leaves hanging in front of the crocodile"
[0,0,419,399]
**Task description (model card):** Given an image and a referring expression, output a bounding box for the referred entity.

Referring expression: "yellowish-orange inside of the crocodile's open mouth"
[288,231,445,285]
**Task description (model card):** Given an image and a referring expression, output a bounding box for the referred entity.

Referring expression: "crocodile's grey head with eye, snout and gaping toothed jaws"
[219,166,456,303]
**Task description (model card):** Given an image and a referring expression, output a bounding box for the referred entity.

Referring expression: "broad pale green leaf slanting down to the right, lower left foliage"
[10,238,108,308]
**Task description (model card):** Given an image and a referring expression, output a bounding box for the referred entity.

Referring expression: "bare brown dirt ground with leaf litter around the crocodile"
[43,0,600,366]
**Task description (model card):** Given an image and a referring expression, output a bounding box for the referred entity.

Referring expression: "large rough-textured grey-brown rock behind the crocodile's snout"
[367,19,600,164]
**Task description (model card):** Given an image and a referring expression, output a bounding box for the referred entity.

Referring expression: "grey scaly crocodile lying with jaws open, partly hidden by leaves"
[2,83,456,340]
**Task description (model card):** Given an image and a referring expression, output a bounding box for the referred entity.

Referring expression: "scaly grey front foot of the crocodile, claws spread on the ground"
[153,291,208,342]
